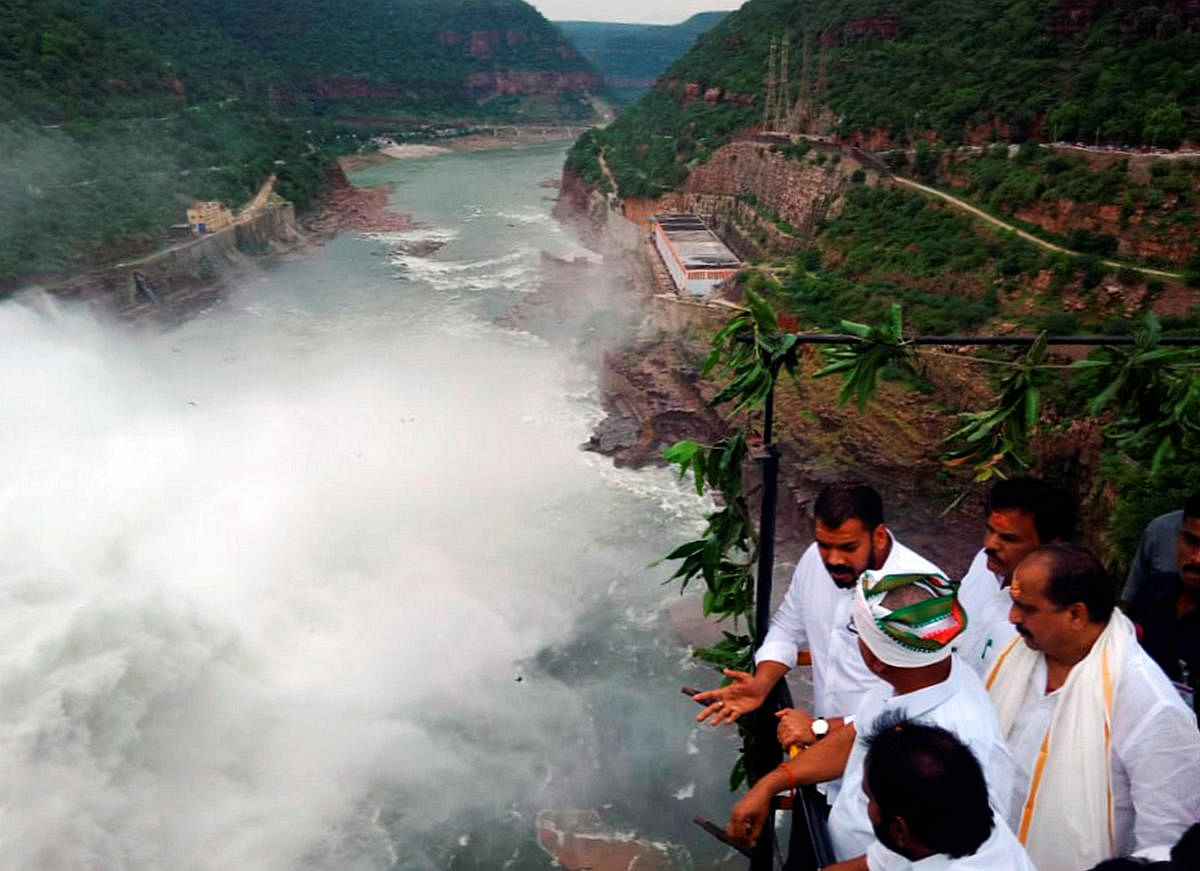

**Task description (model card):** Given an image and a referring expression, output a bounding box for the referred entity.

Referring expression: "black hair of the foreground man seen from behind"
[864,710,995,859]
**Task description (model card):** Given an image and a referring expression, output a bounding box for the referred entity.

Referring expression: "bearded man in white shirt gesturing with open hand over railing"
[695,483,942,744]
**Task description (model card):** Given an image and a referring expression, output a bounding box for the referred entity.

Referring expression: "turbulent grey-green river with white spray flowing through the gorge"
[0,148,733,871]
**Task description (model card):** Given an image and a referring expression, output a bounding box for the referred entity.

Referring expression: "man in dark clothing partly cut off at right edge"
[1121,493,1200,713]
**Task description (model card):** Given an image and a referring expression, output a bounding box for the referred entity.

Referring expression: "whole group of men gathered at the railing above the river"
[696,477,1200,871]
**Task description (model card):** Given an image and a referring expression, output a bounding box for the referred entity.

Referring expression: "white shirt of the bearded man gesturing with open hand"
[754,539,941,716]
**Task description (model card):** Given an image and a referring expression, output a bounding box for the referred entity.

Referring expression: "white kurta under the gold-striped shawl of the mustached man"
[1008,644,1200,855]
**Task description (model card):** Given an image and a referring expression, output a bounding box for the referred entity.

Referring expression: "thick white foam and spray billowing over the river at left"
[0,300,628,871]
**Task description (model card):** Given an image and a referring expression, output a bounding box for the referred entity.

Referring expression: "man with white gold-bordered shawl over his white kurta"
[988,545,1200,871]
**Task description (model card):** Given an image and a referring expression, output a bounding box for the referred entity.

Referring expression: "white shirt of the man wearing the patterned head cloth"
[829,657,1013,861]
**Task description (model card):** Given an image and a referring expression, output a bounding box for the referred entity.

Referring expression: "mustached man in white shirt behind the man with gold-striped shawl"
[954,477,1074,675]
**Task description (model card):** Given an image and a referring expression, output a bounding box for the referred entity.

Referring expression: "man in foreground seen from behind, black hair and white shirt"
[859,714,1036,871]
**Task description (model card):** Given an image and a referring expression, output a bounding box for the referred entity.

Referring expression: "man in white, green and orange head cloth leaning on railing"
[728,571,1013,871]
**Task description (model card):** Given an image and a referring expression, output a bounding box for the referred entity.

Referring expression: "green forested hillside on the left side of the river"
[0,0,595,288]
